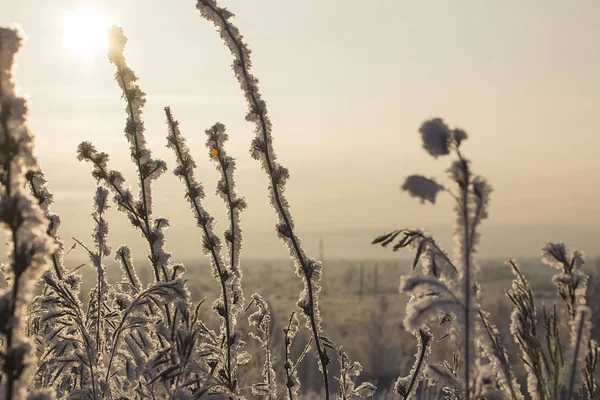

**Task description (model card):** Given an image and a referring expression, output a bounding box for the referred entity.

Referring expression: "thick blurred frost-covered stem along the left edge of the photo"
[0,27,53,399]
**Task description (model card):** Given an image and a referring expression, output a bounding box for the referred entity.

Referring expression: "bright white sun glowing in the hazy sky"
[63,7,110,60]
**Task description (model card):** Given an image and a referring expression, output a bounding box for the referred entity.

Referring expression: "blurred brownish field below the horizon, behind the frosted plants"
[67,249,600,400]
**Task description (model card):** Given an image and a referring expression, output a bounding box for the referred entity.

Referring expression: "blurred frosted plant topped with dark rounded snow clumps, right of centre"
[374,118,491,400]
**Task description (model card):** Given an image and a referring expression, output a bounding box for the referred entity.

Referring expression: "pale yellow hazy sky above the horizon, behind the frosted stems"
[0,0,600,260]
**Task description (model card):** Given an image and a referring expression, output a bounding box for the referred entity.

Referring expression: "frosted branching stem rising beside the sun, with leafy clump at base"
[70,27,230,396]
